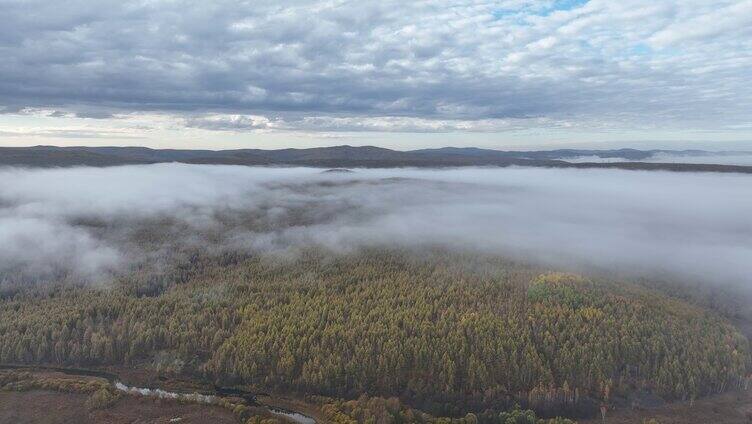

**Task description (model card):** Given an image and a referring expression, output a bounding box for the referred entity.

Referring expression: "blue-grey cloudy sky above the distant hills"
[0,0,752,150]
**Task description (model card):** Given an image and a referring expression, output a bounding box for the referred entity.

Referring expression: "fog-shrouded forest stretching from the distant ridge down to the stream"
[0,164,752,424]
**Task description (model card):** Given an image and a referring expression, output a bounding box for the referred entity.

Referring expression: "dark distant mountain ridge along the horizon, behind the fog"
[0,145,752,173]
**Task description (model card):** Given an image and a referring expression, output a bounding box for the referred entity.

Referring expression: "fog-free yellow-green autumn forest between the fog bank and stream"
[0,251,752,417]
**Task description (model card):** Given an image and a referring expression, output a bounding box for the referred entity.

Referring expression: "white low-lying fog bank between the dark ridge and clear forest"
[0,164,752,283]
